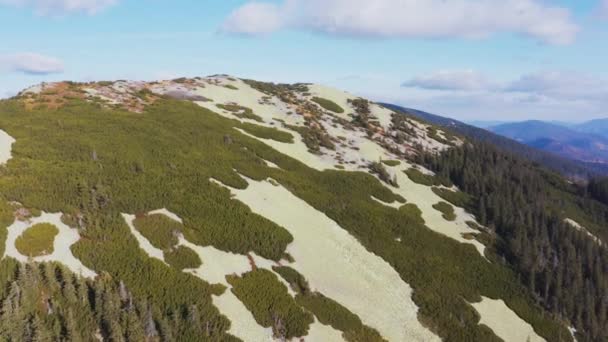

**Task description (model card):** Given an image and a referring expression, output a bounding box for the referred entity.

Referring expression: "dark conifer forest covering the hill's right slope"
[420,142,608,341]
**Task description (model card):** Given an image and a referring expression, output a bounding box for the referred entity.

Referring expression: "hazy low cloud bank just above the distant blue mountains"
[394,71,608,121]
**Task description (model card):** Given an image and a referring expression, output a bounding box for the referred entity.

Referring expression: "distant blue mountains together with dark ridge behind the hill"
[383,103,608,178]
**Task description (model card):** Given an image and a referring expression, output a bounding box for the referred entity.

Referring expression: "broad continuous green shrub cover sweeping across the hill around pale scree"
[0,100,568,341]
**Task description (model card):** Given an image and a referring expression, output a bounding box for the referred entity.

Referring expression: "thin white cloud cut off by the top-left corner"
[0,0,118,15]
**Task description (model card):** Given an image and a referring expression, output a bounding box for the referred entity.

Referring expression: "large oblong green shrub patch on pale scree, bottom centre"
[227,269,314,339]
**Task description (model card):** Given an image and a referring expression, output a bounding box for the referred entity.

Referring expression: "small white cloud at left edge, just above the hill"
[0,52,64,75]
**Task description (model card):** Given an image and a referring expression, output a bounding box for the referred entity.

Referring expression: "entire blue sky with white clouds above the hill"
[0,0,608,122]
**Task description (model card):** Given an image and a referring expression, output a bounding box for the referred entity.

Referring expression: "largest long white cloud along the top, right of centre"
[222,0,578,44]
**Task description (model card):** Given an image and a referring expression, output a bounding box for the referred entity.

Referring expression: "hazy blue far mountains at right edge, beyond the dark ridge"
[490,121,608,163]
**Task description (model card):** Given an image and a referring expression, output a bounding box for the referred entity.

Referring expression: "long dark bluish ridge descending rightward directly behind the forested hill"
[383,104,608,180]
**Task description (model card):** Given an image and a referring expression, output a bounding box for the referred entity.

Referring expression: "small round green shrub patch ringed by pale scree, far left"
[15,223,59,258]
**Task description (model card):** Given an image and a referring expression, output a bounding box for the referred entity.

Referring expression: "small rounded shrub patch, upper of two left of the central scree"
[133,214,183,250]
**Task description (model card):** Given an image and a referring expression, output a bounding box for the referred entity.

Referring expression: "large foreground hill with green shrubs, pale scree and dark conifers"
[0,75,608,341]
